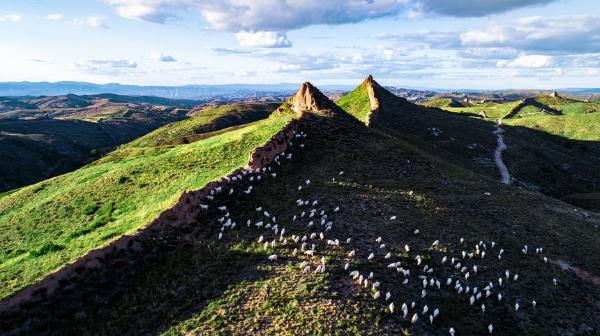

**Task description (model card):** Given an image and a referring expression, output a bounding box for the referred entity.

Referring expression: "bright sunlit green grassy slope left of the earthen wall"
[0,111,289,297]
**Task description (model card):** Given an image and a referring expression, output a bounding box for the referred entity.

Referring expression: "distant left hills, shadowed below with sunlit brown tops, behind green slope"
[0,95,202,191]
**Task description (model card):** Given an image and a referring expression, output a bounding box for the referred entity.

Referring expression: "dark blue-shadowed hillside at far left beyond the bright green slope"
[0,118,160,191]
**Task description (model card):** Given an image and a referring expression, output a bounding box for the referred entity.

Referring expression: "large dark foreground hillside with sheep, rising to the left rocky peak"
[0,84,600,335]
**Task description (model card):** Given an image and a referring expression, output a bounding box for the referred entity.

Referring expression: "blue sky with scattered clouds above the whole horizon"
[0,0,600,89]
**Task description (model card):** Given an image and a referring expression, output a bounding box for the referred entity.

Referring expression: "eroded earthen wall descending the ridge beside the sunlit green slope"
[0,120,297,310]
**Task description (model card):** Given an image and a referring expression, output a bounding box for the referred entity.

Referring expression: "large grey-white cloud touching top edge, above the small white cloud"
[104,0,408,32]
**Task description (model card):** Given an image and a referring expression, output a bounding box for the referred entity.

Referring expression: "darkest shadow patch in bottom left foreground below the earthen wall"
[0,214,280,335]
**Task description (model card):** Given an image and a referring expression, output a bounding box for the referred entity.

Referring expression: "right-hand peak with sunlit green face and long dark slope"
[338,77,600,197]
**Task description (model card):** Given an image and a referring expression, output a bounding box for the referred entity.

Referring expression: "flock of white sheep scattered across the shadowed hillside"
[199,128,558,335]
